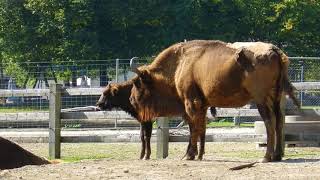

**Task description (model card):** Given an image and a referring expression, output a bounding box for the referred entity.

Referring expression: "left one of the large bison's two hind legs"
[257,103,276,162]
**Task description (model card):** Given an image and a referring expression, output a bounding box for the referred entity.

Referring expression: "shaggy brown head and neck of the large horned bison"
[129,57,184,121]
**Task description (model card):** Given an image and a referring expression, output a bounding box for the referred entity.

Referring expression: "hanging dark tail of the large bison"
[275,47,300,109]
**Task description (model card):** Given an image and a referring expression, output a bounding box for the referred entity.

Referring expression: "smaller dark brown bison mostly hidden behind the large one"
[96,77,215,160]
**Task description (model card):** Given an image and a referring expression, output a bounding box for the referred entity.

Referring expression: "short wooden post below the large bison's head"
[157,117,169,159]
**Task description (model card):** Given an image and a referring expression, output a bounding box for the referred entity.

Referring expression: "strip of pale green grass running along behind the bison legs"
[21,142,320,162]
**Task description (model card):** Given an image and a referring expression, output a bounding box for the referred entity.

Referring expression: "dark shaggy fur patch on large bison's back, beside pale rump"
[235,48,254,72]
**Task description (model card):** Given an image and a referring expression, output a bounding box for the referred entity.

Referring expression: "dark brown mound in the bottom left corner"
[0,137,50,170]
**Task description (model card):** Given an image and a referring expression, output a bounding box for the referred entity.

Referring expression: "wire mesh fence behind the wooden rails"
[0,57,320,128]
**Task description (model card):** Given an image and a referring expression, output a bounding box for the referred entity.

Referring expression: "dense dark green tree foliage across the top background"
[0,0,320,85]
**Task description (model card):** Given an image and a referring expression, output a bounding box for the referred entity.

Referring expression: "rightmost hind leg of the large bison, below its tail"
[273,97,285,161]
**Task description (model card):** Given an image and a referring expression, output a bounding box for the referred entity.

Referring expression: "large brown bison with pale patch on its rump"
[130,40,299,162]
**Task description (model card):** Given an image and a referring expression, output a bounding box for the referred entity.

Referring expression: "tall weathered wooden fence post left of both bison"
[49,83,62,159]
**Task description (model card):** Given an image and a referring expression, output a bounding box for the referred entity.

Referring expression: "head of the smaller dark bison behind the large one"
[96,84,118,110]
